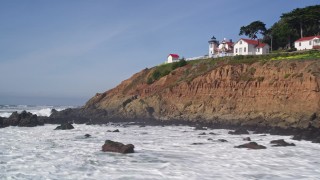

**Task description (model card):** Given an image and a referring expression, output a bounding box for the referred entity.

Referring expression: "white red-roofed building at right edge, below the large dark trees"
[294,36,320,50]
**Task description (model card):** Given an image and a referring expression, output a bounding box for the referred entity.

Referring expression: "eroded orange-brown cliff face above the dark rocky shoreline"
[84,60,320,128]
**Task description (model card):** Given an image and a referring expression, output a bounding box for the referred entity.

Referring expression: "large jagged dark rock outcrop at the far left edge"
[0,111,44,127]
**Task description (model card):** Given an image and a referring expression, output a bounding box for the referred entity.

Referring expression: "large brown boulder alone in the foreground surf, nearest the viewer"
[102,140,134,154]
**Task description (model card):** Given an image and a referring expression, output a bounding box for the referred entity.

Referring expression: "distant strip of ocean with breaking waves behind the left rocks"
[0,105,73,117]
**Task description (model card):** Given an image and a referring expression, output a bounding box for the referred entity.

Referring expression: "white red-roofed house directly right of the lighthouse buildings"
[233,38,270,55]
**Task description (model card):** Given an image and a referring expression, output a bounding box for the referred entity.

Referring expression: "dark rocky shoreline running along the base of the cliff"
[0,108,320,143]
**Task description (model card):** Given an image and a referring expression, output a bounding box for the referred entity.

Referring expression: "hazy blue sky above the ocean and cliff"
[0,0,320,105]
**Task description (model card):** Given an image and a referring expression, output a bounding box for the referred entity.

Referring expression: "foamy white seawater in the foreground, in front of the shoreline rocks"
[0,124,320,180]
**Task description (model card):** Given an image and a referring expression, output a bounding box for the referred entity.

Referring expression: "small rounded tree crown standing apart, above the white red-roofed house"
[239,21,267,39]
